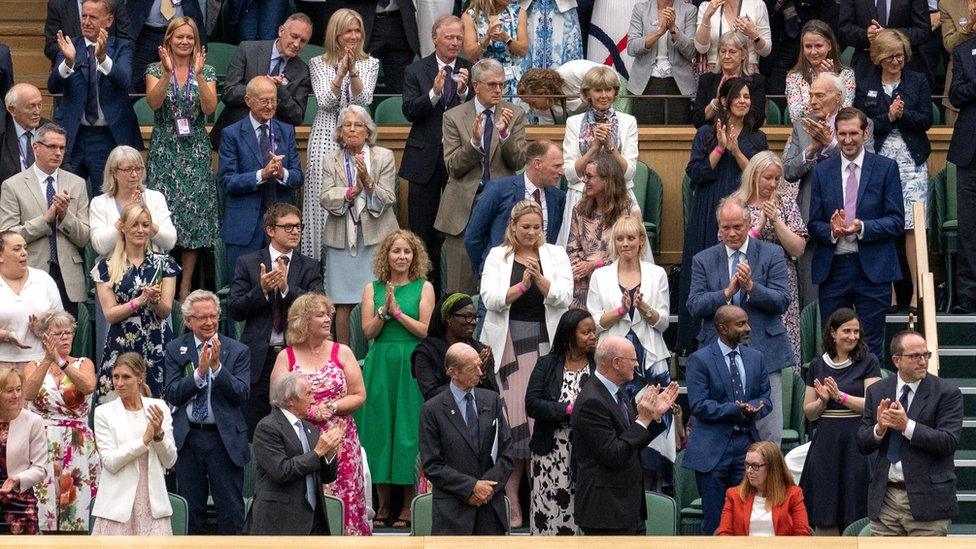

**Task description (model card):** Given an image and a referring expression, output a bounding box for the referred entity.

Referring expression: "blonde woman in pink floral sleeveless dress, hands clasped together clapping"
[271,293,373,536]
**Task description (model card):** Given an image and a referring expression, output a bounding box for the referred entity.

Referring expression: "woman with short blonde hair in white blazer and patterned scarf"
[556,66,637,246]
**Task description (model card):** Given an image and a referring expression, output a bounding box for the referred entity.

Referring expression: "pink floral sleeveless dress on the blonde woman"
[285,343,373,536]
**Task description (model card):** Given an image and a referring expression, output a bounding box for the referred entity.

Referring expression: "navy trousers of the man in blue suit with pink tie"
[820,255,888,363]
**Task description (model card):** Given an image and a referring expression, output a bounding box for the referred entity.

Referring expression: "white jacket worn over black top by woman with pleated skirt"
[481,244,573,368]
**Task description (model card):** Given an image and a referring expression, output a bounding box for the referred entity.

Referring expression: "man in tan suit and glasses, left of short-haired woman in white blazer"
[434,58,525,294]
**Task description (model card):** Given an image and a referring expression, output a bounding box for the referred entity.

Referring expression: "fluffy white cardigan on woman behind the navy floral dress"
[88,189,176,257]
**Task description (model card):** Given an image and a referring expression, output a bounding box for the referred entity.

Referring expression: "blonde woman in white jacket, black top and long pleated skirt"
[481,200,573,528]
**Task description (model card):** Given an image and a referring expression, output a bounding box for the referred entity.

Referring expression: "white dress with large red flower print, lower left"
[28,364,99,532]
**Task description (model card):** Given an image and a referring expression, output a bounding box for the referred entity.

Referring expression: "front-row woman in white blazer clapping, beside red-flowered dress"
[92,353,176,536]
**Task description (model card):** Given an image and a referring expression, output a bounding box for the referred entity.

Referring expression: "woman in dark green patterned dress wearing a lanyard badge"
[146,17,218,301]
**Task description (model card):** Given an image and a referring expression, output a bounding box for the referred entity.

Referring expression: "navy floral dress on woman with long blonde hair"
[91,253,181,405]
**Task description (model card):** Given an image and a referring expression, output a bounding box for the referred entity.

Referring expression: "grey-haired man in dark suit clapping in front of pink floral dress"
[247,372,343,536]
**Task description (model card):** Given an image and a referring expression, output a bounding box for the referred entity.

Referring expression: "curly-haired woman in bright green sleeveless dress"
[356,229,435,528]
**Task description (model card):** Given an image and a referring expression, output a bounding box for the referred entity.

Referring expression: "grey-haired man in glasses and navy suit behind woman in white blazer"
[164,290,251,536]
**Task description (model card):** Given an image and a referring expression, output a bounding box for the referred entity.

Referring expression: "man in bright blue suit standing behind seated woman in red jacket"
[682,305,772,536]
